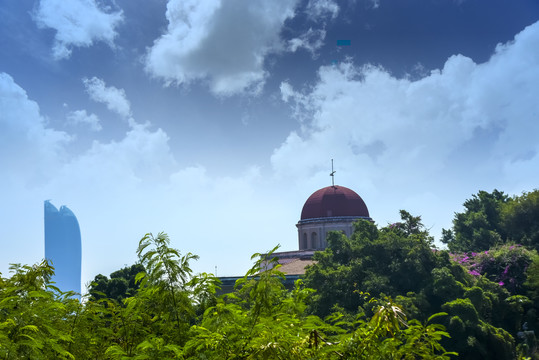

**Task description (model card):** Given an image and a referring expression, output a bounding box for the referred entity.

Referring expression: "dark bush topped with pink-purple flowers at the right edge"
[450,245,535,294]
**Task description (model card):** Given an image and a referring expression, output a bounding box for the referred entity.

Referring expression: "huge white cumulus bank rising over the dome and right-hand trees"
[272,23,539,236]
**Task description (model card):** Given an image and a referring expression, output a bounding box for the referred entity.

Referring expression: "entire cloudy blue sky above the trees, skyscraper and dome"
[0,0,539,284]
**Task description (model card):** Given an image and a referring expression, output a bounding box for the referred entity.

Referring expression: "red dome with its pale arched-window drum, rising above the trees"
[296,185,372,250]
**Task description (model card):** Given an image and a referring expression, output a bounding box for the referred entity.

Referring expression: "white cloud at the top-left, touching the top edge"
[34,0,123,59]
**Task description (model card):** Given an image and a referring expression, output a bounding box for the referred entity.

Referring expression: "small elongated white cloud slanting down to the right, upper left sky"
[82,77,131,118]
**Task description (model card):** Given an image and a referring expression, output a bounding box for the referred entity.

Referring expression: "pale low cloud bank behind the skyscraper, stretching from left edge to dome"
[0,73,299,292]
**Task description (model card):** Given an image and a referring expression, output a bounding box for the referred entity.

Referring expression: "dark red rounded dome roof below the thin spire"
[301,186,369,220]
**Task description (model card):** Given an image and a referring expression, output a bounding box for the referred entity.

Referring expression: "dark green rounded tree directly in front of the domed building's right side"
[305,211,436,316]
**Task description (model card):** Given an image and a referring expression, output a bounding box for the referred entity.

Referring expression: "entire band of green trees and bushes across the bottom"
[0,190,539,359]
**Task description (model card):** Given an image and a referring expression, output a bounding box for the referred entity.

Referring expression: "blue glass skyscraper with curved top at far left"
[45,200,82,293]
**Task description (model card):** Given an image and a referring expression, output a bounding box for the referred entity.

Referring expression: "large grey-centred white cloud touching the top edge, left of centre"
[146,0,296,96]
